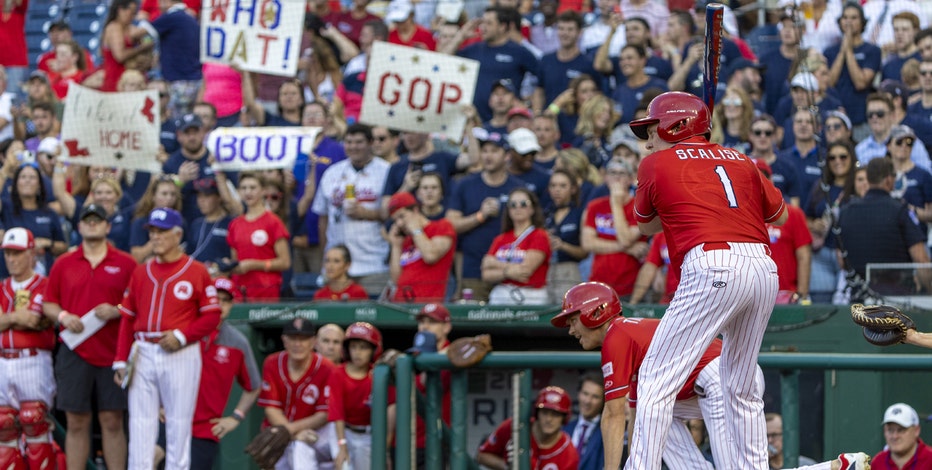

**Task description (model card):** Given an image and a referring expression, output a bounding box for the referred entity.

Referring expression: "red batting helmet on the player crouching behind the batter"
[550,282,621,328]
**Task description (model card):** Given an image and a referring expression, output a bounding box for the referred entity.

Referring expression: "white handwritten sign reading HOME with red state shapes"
[61,83,162,173]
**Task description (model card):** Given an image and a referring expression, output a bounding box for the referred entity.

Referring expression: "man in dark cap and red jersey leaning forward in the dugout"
[259,318,335,470]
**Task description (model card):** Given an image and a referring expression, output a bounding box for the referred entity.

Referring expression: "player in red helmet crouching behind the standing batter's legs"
[550,282,870,470]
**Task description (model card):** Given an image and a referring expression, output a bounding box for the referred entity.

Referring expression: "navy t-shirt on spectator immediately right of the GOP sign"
[456,40,538,121]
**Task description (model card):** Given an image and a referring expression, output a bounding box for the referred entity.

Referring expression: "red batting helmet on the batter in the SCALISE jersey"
[630,91,712,144]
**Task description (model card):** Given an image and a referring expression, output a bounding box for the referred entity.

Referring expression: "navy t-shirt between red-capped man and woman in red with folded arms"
[447,173,526,279]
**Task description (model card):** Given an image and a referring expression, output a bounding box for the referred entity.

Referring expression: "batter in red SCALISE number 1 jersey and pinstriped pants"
[628,92,787,470]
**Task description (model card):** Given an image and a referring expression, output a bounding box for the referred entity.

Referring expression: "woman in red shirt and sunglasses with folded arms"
[482,187,551,305]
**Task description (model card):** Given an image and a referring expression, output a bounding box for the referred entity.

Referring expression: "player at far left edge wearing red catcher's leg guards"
[0,227,56,470]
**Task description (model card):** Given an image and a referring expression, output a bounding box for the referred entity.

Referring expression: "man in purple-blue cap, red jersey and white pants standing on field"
[113,208,220,470]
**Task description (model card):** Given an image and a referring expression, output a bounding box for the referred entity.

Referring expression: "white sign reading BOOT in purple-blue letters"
[207,127,320,171]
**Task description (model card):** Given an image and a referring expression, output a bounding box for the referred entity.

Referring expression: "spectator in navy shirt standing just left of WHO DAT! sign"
[152,0,203,116]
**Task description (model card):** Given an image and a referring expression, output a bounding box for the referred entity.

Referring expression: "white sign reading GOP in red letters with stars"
[359,41,479,140]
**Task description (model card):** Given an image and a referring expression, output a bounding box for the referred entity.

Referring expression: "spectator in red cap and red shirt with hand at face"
[388,192,456,303]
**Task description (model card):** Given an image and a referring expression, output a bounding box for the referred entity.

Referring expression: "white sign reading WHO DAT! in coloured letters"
[201,0,304,77]
